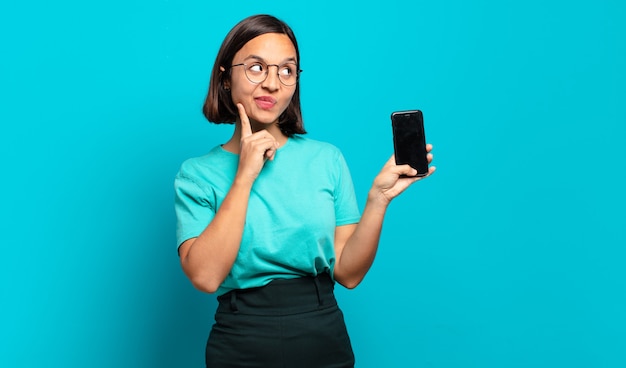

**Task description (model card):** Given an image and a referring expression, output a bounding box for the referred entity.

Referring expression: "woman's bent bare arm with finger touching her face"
[179,104,278,293]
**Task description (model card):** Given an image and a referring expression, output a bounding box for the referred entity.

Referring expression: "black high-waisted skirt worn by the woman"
[206,274,354,368]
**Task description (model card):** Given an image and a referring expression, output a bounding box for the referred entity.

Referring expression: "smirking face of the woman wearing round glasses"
[227,33,298,128]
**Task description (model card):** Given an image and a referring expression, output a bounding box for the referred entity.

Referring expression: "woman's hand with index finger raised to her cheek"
[237,103,278,181]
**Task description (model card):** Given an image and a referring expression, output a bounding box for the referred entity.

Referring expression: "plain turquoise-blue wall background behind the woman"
[0,0,626,368]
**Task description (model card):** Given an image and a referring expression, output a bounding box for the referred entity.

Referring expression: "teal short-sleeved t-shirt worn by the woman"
[174,136,360,295]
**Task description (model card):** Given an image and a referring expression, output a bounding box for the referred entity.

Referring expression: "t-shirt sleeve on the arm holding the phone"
[335,152,361,226]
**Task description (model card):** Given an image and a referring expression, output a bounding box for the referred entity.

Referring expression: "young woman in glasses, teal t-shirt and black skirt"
[175,15,434,368]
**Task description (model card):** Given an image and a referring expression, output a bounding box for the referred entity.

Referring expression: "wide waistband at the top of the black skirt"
[217,273,337,316]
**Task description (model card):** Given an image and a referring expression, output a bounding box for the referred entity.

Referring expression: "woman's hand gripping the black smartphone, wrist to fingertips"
[369,144,435,205]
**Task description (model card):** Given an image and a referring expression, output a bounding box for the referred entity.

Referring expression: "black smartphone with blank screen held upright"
[391,110,428,176]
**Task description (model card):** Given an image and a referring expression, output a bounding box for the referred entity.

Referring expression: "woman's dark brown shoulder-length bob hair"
[202,14,306,136]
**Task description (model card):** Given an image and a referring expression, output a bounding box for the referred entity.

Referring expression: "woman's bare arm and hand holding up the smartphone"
[334,145,435,289]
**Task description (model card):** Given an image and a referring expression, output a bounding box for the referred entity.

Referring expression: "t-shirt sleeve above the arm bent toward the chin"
[174,173,215,246]
